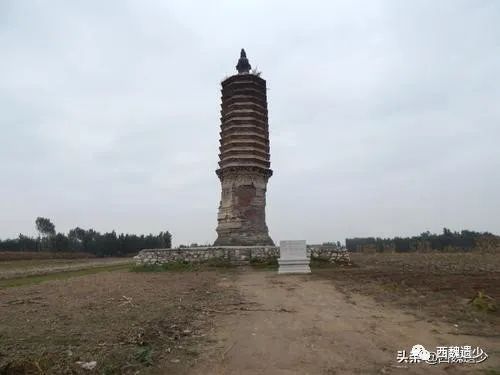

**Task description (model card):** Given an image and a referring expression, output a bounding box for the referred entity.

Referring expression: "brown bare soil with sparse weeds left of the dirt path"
[0,271,240,374]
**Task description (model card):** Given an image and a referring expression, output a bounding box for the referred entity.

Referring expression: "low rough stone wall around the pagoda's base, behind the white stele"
[134,246,350,265]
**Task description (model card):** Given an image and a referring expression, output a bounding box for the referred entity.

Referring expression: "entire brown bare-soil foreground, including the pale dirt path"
[0,253,500,374]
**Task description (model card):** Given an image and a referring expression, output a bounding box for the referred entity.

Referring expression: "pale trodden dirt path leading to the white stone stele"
[190,271,500,375]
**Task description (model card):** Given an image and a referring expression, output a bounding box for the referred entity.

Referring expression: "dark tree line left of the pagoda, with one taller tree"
[0,217,172,257]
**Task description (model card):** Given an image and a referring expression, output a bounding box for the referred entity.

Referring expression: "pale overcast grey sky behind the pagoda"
[0,0,500,245]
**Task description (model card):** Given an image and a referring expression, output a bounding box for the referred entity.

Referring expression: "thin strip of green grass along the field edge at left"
[0,264,130,288]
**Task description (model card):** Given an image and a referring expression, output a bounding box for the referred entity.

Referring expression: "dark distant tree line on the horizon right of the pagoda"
[345,228,494,252]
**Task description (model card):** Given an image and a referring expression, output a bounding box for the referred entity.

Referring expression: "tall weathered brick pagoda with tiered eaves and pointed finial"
[214,49,274,246]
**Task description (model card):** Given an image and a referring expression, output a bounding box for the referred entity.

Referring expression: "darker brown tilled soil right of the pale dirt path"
[316,252,500,338]
